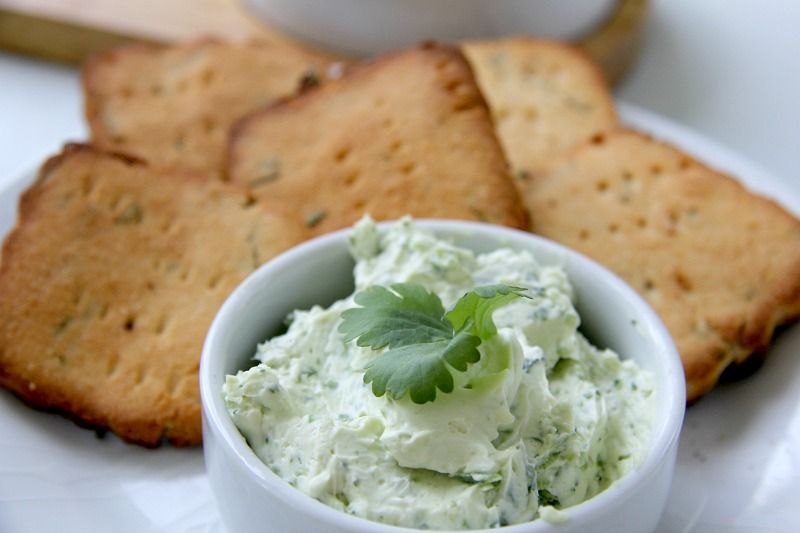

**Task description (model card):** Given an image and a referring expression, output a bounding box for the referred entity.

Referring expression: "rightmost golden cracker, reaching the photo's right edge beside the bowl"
[525,131,800,401]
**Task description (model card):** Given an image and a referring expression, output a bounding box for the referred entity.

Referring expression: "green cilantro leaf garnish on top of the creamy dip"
[339,283,525,404]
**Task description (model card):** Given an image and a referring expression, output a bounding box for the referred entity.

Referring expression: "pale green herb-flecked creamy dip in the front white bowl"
[223,219,655,529]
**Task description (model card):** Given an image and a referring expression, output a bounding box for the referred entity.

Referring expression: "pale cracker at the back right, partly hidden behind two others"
[462,37,619,179]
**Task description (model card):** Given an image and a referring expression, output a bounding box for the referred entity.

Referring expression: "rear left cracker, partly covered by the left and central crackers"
[82,40,338,175]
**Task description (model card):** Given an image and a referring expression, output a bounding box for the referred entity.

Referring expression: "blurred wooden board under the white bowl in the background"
[0,0,648,83]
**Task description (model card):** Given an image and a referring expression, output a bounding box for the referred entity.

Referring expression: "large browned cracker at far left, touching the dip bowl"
[0,145,305,446]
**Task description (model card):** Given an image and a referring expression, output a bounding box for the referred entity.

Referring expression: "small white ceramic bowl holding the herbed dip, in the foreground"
[200,220,685,533]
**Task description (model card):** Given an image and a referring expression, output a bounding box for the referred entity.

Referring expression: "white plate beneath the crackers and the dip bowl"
[0,104,800,533]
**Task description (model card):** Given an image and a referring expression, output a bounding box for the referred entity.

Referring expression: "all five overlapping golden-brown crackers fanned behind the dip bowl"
[0,32,800,446]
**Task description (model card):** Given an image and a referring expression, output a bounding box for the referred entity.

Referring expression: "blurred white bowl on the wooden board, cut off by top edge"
[244,0,617,56]
